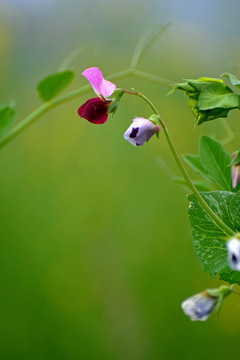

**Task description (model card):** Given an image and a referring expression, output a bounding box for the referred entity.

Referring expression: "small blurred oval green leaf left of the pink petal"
[37,70,74,101]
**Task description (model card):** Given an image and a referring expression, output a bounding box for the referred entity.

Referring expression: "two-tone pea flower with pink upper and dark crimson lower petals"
[78,67,116,124]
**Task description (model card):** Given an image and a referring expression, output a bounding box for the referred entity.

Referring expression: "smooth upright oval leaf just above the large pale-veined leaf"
[200,136,232,191]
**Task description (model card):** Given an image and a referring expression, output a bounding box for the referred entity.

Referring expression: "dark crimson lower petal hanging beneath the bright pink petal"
[78,98,109,124]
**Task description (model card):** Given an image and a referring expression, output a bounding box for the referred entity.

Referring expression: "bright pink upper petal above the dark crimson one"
[82,67,116,100]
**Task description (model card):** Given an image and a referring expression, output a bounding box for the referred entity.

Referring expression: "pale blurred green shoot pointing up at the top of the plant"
[130,22,171,68]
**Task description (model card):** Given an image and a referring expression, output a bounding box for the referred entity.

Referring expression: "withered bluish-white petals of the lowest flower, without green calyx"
[181,292,216,321]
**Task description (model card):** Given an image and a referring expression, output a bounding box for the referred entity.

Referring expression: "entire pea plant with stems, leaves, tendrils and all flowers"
[0,23,240,321]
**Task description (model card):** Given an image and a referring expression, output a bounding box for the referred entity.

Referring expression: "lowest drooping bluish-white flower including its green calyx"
[181,285,232,321]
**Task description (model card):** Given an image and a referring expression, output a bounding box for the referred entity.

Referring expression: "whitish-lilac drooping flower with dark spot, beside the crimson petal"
[124,117,160,146]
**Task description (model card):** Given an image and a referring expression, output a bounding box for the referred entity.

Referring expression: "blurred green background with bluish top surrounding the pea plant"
[0,0,240,360]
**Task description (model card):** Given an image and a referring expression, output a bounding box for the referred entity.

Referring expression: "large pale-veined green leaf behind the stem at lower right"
[188,191,240,284]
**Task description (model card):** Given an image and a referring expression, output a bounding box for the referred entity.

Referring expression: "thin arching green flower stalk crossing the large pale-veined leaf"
[133,92,235,236]
